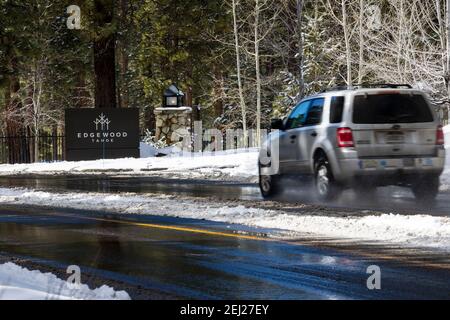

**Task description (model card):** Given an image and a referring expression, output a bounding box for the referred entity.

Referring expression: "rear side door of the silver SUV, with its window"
[297,98,325,173]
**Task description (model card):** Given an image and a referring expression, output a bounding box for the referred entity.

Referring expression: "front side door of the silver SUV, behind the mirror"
[280,100,310,173]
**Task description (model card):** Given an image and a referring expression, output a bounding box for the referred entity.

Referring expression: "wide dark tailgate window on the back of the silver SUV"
[353,94,434,124]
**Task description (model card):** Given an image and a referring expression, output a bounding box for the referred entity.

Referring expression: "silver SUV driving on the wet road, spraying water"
[259,84,445,201]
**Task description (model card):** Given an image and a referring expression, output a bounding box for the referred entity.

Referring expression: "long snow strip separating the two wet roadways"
[0,188,450,251]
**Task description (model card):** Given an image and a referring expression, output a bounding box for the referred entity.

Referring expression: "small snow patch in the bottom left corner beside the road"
[0,262,130,300]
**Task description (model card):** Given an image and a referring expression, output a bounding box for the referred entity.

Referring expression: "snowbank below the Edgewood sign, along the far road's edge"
[0,149,258,180]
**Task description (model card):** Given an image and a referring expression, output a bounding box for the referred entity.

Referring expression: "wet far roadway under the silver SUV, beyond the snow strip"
[0,175,450,216]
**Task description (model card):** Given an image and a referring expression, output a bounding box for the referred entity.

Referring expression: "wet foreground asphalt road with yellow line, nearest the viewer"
[0,206,450,299]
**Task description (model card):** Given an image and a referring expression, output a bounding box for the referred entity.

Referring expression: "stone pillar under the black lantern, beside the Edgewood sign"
[155,107,192,145]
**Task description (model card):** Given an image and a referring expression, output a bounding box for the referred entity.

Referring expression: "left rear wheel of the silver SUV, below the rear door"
[314,155,342,201]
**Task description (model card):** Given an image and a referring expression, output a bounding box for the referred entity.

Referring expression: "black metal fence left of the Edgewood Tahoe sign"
[0,135,65,163]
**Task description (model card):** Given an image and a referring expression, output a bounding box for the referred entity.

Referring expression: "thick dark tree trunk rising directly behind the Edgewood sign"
[94,0,117,108]
